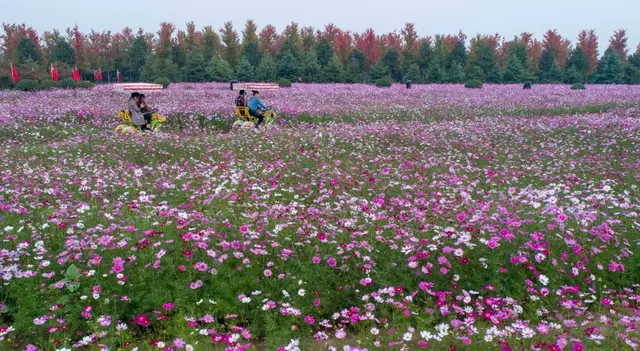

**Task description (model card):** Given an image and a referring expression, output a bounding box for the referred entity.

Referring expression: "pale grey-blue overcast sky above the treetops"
[0,0,640,53]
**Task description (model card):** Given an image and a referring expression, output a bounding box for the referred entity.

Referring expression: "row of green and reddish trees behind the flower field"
[0,20,640,87]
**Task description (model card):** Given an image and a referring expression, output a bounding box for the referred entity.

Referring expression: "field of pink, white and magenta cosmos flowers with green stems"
[0,84,640,351]
